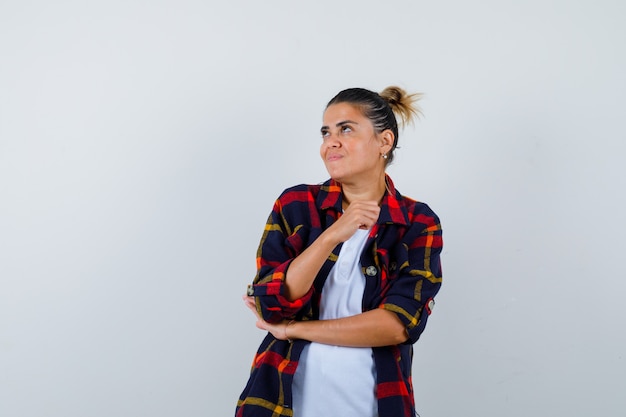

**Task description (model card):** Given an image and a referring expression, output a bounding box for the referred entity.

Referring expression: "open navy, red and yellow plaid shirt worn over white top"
[235,177,443,417]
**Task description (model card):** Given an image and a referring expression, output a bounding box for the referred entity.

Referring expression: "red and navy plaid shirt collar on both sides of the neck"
[318,174,409,226]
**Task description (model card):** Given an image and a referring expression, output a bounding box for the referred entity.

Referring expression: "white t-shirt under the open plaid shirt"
[292,230,378,417]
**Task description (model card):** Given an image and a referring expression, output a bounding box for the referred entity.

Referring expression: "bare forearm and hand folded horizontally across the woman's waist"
[244,297,408,347]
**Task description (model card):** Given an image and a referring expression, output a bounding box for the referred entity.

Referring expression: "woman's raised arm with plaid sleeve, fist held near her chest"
[247,186,380,323]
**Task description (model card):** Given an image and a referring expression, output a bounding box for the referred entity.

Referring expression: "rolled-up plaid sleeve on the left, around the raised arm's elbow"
[248,193,313,323]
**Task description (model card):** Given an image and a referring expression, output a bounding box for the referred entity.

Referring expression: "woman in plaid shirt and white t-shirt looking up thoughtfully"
[236,87,442,417]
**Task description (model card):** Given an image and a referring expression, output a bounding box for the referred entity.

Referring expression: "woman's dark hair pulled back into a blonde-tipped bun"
[326,86,422,165]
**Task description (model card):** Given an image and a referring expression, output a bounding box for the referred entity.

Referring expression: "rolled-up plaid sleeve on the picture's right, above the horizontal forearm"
[380,206,443,343]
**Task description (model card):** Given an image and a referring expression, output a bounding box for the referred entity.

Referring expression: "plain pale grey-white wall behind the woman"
[0,0,626,417]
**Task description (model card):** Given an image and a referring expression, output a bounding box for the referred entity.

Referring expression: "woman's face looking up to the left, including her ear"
[320,103,391,184]
